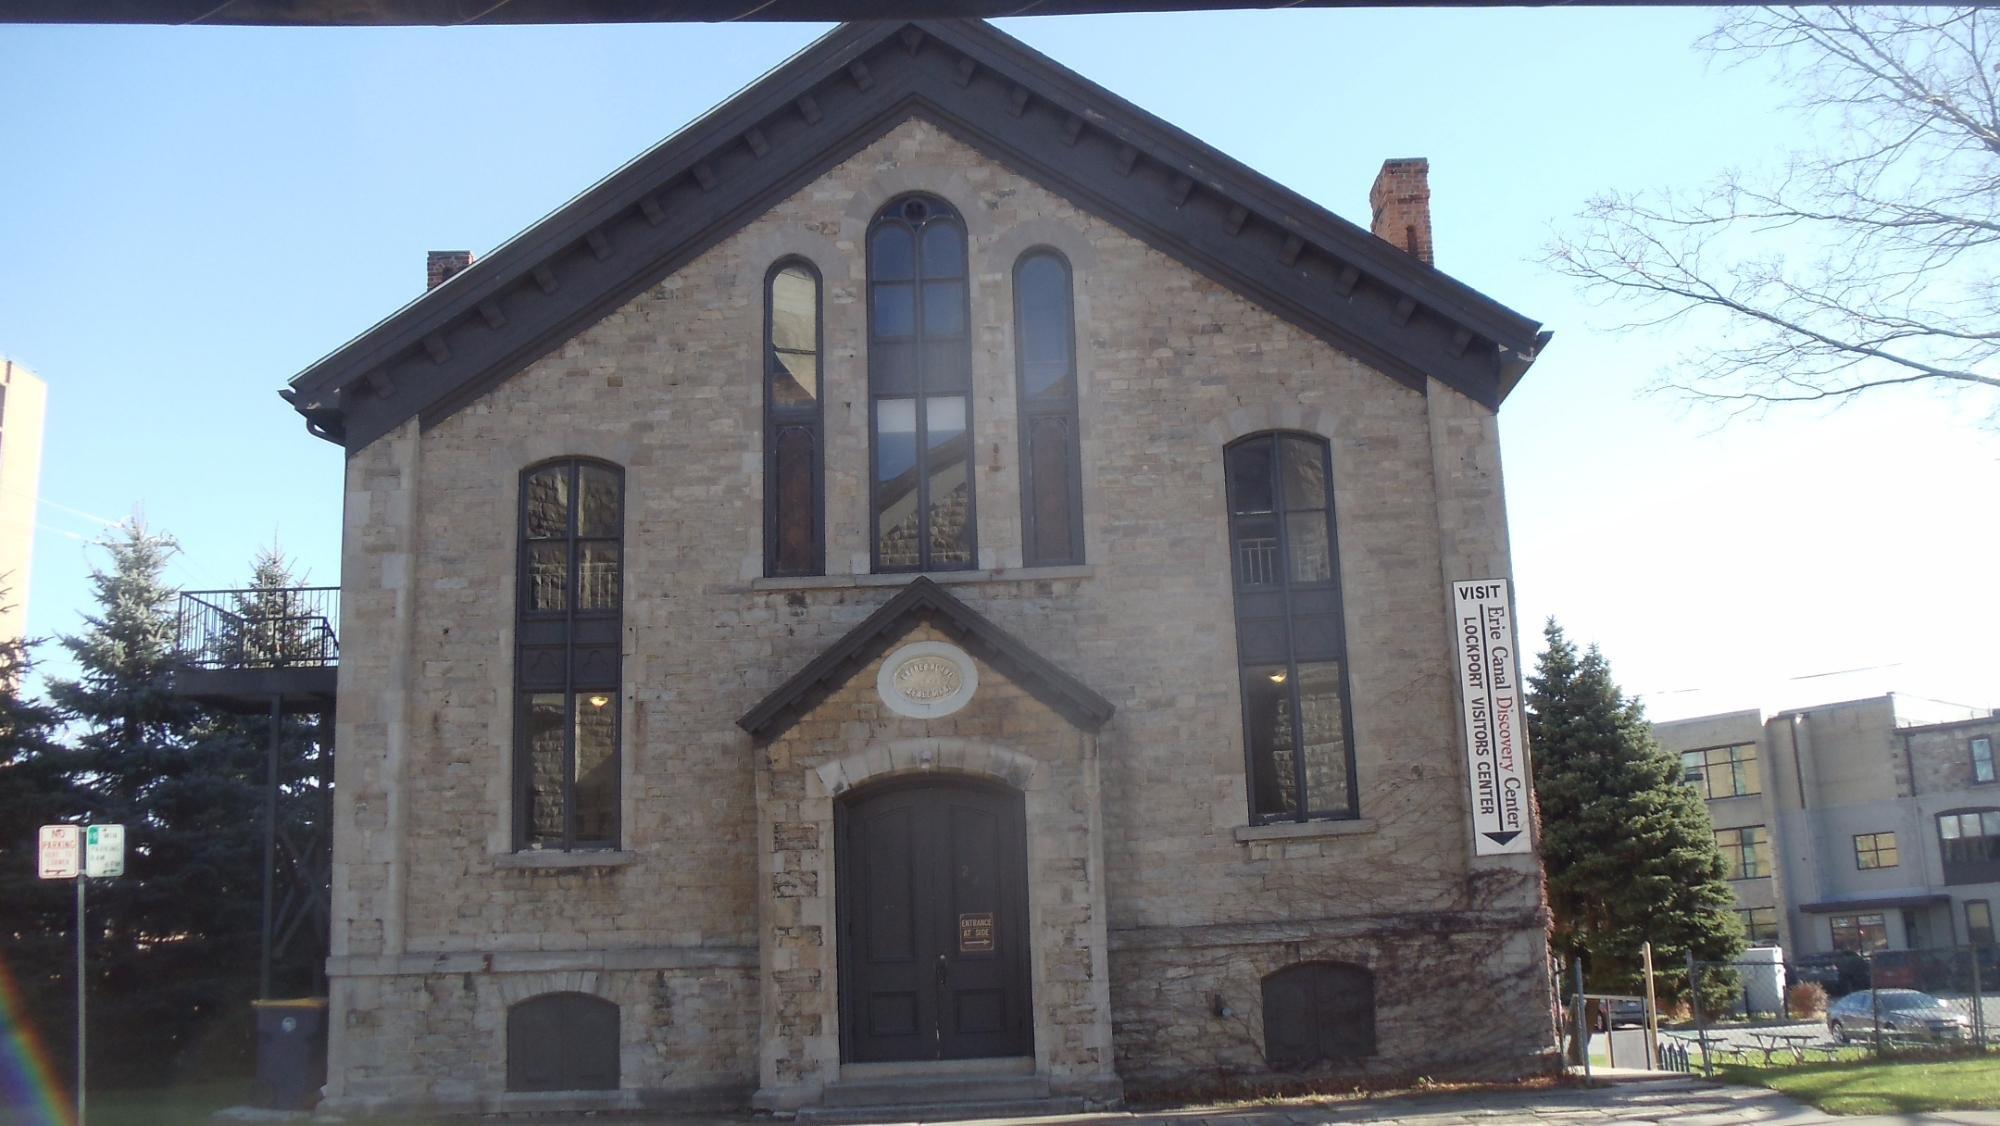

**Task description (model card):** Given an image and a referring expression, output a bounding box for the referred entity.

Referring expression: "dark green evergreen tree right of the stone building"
[1528,618,1744,1002]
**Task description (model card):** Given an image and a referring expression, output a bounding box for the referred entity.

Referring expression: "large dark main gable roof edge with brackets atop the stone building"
[280,20,1546,450]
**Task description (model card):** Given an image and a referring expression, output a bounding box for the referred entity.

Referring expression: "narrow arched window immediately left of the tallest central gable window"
[764,258,826,576]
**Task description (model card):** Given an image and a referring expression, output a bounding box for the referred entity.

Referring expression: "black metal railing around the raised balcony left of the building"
[174,586,340,668]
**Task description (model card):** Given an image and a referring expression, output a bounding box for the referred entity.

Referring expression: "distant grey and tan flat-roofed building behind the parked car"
[1654,694,2000,960]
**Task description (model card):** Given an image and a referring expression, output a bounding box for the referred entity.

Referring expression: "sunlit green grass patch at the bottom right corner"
[1716,1056,2000,1114]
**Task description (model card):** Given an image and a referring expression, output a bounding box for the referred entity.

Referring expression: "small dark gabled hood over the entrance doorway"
[736,576,1114,744]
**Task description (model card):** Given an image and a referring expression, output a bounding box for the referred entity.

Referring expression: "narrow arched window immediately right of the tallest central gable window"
[1014,246,1084,566]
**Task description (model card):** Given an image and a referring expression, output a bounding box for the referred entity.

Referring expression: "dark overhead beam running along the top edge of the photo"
[0,0,1736,24]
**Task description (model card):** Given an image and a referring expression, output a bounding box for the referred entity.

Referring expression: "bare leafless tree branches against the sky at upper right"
[1546,6,2000,426]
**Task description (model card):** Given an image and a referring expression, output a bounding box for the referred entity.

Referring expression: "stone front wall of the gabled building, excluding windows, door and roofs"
[328,118,1552,1110]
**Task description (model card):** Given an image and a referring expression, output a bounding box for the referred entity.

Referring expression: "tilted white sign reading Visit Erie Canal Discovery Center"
[1452,578,1534,856]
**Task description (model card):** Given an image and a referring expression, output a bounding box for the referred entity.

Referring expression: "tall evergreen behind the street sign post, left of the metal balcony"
[50,522,262,1082]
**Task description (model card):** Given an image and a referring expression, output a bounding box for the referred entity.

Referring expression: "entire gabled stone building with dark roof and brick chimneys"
[288,22,1552,1116]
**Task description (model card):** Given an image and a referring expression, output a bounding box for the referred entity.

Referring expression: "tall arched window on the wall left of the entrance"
[514,458,624,848]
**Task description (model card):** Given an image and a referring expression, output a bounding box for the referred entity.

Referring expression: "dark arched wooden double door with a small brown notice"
[834,780,1034,1062]
